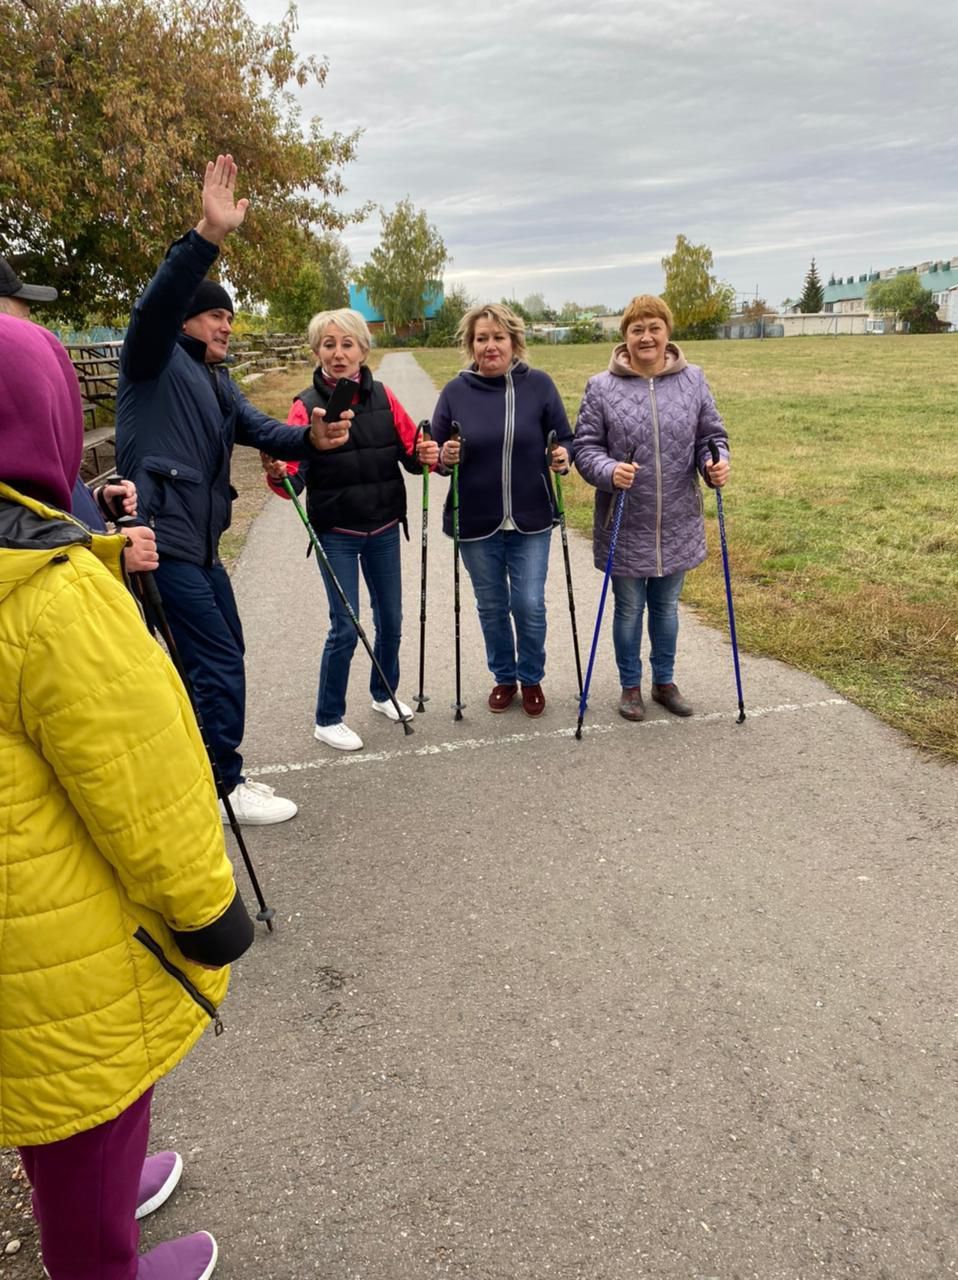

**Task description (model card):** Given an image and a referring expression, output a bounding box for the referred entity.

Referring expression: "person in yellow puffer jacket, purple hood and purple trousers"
[0,315,252,1280]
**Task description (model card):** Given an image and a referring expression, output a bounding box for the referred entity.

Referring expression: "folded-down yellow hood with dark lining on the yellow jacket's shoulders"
[0,481,126,605]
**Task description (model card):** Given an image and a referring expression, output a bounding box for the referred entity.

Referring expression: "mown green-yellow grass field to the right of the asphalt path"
[415,334,958,760]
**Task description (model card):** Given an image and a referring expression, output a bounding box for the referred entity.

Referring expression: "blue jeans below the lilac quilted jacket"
[612,570,685,689]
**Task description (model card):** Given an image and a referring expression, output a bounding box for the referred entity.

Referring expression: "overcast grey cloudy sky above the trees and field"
[247,0,958,307]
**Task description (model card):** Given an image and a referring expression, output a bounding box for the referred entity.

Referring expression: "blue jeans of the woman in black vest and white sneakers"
[316,525,402,724]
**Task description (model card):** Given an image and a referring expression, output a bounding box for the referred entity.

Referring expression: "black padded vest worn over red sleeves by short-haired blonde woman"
[296,365,406,534]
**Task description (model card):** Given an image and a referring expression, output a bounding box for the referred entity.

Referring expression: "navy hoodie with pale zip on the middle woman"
[433,361,572,541]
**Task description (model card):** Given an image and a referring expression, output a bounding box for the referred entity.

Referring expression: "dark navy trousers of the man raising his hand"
[156,556,246,792]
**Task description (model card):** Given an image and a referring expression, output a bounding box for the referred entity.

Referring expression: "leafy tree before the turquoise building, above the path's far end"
[357,197,450,333]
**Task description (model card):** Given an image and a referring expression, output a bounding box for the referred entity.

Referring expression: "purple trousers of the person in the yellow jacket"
[19,1088,152,1280]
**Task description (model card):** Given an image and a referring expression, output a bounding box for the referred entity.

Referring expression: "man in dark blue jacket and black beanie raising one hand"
[117,156,324,823]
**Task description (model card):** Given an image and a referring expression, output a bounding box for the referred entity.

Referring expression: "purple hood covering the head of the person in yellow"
[0,315,83,511]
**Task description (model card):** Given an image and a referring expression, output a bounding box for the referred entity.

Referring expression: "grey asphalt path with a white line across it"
[143,355,958,1280]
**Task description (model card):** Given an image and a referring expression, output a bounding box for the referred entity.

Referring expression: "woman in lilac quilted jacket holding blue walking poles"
[575,294,729,721]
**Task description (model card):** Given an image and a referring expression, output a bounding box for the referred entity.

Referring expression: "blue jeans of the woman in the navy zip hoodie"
[460,529,552,685]
